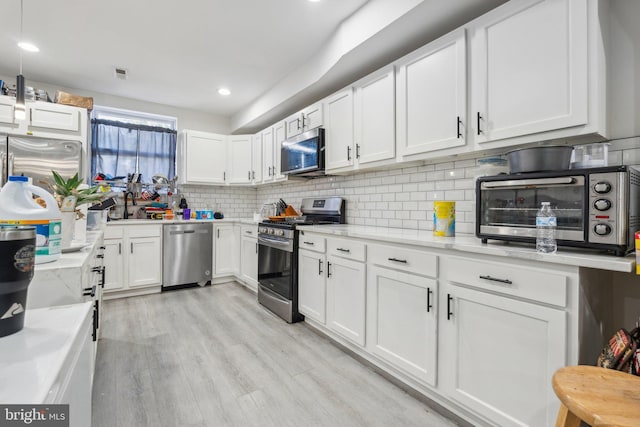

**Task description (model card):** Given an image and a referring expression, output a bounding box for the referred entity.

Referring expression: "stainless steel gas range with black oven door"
[258,197,346,323]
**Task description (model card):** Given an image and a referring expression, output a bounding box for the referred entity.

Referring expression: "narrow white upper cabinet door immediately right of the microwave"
[324,88,355,170]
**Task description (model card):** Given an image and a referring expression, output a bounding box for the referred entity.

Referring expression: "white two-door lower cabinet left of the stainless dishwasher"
[104,224,162,294]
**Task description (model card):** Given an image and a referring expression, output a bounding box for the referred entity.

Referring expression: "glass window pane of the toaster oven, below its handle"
[480,185,585,232]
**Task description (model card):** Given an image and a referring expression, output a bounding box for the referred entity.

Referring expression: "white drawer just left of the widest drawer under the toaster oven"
[369,245,438,277]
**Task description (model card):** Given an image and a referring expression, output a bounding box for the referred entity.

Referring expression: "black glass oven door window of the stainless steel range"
[258,245,293,300]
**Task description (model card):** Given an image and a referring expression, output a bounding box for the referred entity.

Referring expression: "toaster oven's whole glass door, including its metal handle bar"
[478,176,588,241]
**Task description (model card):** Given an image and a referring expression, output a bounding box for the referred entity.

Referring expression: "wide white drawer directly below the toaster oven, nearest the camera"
[440,257,568,307]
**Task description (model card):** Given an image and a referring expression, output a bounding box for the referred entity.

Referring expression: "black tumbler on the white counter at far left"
[0,226,36,337]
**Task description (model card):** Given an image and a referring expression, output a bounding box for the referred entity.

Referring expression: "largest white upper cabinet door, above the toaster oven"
[471,0,589,143]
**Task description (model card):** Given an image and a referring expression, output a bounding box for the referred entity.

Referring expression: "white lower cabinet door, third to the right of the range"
[367,266,438,386]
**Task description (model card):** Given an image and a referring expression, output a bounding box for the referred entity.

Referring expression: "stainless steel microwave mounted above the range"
[280,128,324,177]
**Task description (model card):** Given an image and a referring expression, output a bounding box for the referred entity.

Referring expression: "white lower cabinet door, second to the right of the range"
[327,256,366,346]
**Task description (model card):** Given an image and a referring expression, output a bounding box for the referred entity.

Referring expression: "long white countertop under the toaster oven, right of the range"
[298,224,636,273]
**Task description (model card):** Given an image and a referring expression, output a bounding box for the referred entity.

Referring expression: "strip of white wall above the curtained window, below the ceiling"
[0,75,229,134]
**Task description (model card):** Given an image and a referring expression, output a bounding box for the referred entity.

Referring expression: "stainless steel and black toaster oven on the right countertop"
[476,166,640,256]
